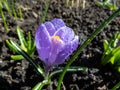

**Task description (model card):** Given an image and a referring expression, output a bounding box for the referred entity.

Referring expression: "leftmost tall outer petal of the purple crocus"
[35,24,51,62]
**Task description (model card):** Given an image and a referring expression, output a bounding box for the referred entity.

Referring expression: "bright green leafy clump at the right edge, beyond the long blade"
[101,32,120,72]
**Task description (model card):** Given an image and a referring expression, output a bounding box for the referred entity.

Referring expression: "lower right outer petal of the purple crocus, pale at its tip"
[54,36,79,65]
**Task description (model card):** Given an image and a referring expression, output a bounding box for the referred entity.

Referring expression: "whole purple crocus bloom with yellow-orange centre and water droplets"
[35,19,79,71]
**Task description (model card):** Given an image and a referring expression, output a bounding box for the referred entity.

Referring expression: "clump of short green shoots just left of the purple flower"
[6,27,35,60]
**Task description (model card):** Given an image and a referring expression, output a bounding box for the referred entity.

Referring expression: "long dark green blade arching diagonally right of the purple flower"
[57,8,120,90]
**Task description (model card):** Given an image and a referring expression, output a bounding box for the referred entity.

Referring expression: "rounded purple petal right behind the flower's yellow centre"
[54,26,74,43]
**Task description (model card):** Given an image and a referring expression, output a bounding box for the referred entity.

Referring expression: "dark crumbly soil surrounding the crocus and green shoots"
[0,0,120,90]
